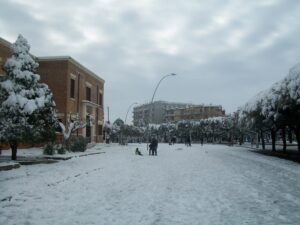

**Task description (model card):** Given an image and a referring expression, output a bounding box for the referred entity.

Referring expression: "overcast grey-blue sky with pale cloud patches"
[0,0,300,121]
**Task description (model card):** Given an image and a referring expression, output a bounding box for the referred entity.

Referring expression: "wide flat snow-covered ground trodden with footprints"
[0,144,300,225]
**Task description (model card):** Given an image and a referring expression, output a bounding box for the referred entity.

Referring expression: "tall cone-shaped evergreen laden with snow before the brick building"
[0,35,56,160]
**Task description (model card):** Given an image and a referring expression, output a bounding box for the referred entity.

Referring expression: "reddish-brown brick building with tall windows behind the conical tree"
[0,38,105,142]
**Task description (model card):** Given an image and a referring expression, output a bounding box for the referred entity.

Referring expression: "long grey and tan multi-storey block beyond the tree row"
[133,101,225,126]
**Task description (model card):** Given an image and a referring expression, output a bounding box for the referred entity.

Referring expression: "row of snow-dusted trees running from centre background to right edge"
[126,64,300,152]
